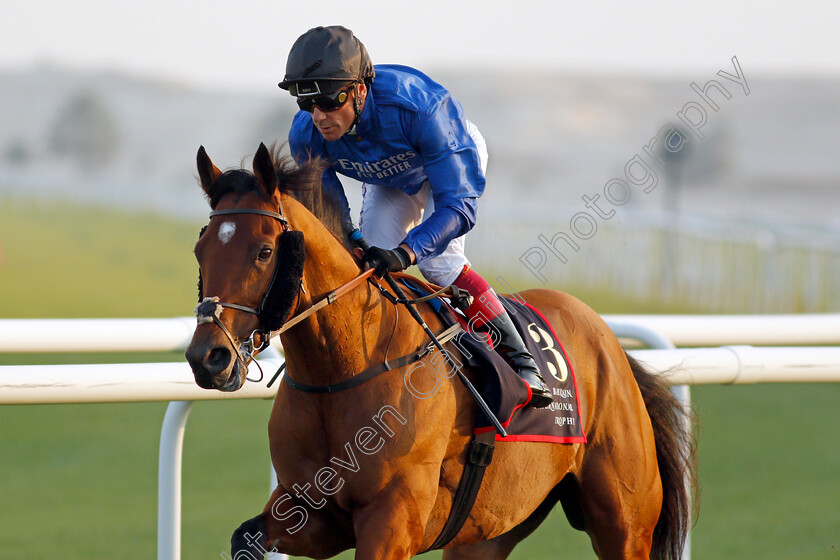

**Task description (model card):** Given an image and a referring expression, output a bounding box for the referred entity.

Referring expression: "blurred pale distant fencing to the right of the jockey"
[470,200,840,313]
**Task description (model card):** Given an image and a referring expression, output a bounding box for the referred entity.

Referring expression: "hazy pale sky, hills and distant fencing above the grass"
[0,0,840,312]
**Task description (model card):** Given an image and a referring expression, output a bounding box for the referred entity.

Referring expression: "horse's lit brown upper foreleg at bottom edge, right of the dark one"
[353,480,436,560]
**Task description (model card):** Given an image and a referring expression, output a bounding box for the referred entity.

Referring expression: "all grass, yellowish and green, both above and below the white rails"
[0,200,840,560]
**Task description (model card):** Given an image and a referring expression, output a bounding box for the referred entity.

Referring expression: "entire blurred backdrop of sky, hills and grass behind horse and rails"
[0,0,840,560]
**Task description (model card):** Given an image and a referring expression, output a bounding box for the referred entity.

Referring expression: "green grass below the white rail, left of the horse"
[0,401,270,560]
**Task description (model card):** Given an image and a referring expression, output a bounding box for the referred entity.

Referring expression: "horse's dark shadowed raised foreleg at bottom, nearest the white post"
[231,485,354,558]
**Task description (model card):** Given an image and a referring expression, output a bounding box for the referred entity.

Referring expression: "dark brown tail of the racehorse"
[627,355,698,560]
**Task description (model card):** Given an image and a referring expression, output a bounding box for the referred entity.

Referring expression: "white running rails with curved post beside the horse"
[0,314,840,560]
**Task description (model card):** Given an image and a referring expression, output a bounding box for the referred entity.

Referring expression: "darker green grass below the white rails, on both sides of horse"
[0,384,840,560]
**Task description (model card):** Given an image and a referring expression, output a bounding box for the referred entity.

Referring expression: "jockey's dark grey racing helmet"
[277,25,376,97]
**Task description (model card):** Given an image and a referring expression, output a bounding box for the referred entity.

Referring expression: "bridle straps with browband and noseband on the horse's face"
[195,206,296,382]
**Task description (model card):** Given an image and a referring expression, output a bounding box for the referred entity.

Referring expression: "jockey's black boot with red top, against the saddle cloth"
[453,266,551,408]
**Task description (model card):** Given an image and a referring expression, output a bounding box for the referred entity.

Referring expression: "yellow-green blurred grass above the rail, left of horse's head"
[0,198,201,318]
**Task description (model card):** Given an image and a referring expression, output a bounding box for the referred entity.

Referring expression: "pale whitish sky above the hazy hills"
[0,0,840,92]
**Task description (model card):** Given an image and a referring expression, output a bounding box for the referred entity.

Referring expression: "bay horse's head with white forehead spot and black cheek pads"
[186,144,304,391]
